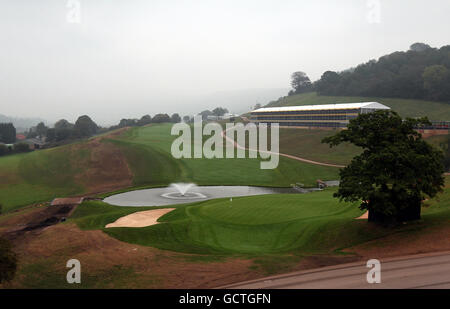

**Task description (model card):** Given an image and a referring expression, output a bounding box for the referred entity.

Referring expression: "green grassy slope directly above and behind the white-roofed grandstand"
[266,92,450,121]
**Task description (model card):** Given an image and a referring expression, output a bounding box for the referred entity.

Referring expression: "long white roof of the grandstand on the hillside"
[252,102,391,113]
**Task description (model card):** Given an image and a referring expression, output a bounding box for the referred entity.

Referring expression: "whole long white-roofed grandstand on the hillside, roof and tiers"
[250,102,390,129]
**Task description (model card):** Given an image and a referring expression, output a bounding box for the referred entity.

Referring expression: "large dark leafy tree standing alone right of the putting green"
[322,111,444,223]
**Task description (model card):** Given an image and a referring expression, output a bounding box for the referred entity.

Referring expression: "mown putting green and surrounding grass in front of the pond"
[69,173,450,255]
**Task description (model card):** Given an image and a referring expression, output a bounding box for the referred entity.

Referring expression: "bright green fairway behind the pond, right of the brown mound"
[110,124,338,187]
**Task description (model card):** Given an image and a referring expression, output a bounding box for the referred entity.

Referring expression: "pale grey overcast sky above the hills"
[0,0,450,124]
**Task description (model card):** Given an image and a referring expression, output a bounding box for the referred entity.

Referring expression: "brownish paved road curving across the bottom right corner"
[223,251,450,289]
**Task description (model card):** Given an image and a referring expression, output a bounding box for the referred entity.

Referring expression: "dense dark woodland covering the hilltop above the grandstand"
[289,43,450,103]
